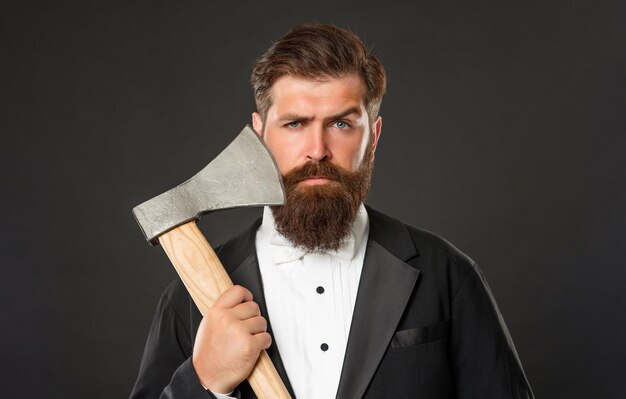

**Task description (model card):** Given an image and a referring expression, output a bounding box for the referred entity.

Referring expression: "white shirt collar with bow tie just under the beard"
[260,203,369,264]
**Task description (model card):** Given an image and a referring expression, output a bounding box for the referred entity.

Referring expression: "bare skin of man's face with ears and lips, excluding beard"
[252,75,381,180]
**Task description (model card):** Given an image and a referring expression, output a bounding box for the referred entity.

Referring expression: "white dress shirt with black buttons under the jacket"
[214,204,369,399]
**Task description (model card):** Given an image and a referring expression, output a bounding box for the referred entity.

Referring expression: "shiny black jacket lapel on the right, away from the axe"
[337,208,419,399]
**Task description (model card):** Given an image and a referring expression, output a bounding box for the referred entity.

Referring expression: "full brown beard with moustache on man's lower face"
[272,151,373,251]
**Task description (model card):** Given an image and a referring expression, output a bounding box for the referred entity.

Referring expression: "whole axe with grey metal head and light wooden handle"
[133,125,290,399]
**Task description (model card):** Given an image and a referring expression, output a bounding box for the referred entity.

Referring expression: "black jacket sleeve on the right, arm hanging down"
[450,264,534,399]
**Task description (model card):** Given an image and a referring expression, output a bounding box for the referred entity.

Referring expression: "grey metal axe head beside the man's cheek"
[133,125,285,245]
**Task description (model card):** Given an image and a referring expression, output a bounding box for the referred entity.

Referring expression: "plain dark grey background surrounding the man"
[0,0,626,398]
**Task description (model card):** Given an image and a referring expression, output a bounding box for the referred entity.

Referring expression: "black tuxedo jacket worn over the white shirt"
[131,208,533,399]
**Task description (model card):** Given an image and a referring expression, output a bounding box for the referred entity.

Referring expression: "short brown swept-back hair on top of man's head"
[250,24,387,122]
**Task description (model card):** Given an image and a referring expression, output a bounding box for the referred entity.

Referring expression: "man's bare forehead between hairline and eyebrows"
[269,74,365,113]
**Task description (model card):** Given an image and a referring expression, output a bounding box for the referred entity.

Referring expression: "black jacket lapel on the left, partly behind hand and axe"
[218,220,295,398]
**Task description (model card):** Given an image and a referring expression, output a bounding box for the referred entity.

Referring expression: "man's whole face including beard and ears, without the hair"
[253,76,381,251]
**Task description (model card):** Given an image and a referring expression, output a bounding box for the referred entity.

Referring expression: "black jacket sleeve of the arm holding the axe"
[130,292,215,399]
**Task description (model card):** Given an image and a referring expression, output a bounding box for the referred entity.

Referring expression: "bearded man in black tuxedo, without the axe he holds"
[131,25,533,399]
